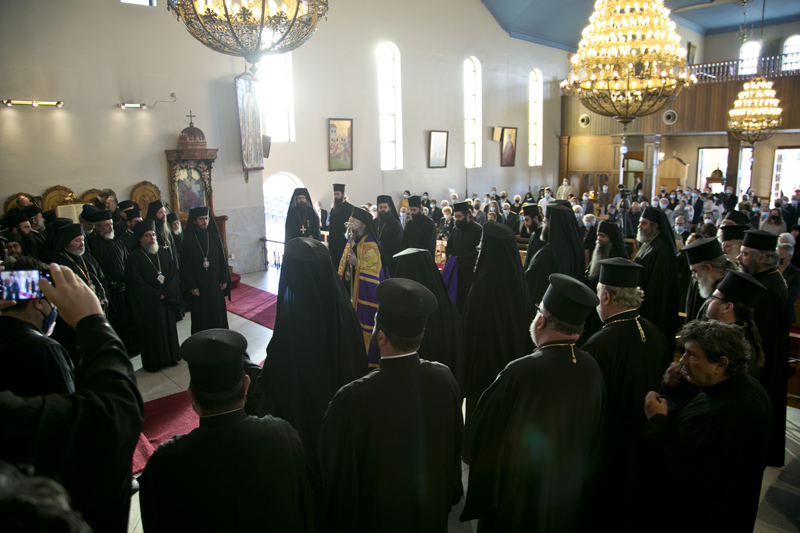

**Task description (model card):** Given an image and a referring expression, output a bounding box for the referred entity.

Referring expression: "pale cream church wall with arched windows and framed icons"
[0,0,569,272]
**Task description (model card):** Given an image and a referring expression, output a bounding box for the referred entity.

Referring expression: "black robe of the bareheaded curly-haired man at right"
[641,374,772,532]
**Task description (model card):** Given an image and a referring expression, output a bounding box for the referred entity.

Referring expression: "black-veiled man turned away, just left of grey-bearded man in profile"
[525,204,585,304]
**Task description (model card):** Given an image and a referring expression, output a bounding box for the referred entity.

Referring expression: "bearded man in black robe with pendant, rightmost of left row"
[180,207,231,334]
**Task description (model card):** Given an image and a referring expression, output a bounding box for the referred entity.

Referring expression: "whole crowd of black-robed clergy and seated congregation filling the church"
[0,180,800,531]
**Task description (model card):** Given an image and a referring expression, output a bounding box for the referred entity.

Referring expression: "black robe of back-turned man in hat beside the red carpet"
[139,409,314,532]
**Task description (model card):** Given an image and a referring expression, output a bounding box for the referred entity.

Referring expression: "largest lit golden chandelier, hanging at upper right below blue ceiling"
[561,0,697,127]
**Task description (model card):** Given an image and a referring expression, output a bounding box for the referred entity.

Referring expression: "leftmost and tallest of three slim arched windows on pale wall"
[378,41,403,170]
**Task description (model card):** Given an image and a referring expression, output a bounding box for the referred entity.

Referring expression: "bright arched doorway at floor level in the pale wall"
[262,172,303,270]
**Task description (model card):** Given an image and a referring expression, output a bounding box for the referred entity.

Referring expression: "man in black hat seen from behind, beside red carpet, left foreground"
[139,329,313,531]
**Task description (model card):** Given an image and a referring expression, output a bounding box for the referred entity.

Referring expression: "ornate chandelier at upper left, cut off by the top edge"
[167,0,328,70]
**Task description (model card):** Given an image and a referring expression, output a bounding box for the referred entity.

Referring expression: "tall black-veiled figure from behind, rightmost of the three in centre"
[462,222,532,421]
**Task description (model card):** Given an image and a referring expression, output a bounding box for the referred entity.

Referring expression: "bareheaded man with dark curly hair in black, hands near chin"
[640,320,768,533]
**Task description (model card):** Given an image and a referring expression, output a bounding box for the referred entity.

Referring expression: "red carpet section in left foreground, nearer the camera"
[133,392,200,474]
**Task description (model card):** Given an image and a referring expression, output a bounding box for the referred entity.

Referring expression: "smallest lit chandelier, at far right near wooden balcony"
[728,76,781,144]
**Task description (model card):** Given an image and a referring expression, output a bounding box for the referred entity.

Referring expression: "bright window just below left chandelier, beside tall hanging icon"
[258,52,295,142]
